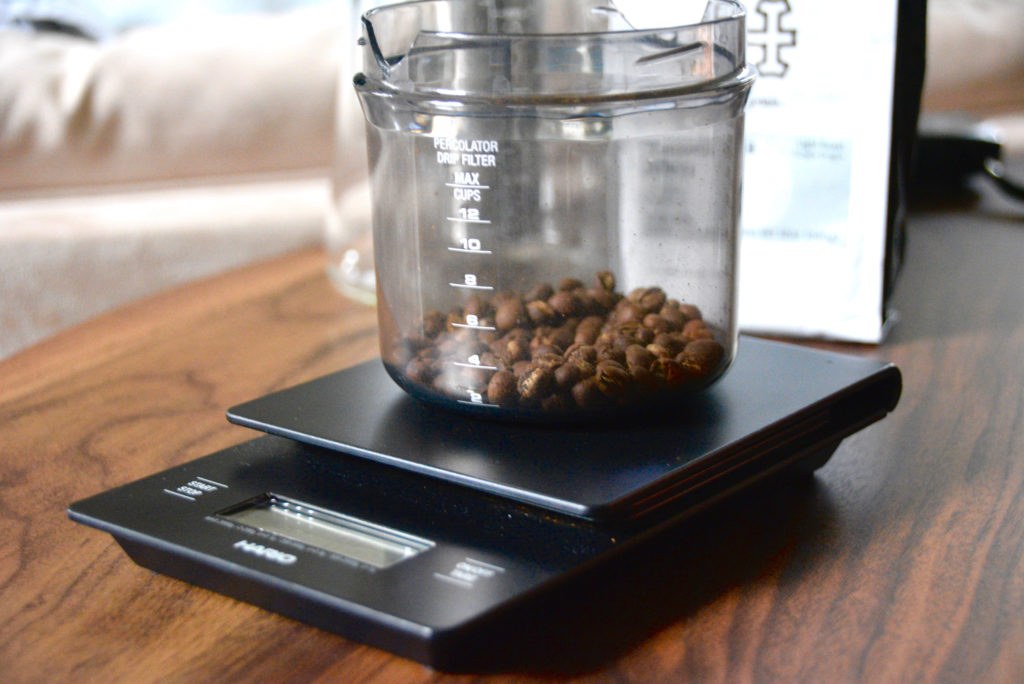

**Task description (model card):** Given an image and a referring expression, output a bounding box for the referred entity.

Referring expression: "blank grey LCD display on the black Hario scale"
[218,494,434,568]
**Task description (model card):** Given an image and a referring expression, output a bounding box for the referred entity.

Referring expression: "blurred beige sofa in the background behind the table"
[0,0,1024,357]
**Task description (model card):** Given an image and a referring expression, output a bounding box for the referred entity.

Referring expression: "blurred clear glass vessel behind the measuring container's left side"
[326,0,397,304]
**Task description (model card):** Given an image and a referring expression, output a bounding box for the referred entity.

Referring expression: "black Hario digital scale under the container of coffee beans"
[69,337,901,669]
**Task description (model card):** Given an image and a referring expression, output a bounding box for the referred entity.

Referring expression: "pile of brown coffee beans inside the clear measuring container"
[386,271,727,412]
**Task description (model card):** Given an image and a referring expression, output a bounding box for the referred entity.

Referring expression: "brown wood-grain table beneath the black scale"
[0,179,1024,683]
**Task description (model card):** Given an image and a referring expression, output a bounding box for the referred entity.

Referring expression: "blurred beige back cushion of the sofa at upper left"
[0,3,346,190]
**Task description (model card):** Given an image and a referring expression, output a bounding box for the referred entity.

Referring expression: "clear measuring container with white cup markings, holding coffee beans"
[355,0,754,420]
